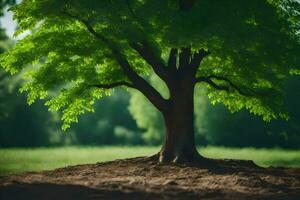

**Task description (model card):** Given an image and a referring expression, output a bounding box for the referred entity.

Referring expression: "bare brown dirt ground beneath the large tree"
[0,158,300,200]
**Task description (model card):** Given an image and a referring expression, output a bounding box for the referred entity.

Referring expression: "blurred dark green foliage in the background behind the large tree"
[0,0,300,149]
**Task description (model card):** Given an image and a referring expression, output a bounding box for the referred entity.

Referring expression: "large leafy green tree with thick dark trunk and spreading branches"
[1,0,300,164]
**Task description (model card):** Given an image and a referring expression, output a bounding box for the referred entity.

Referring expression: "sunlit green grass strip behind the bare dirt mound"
[0,147,300,175]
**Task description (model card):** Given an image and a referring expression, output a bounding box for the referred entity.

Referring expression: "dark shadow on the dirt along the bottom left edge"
[0,183,161,200]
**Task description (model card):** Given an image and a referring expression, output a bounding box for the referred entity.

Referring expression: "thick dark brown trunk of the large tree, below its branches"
[159,77,203,163]
